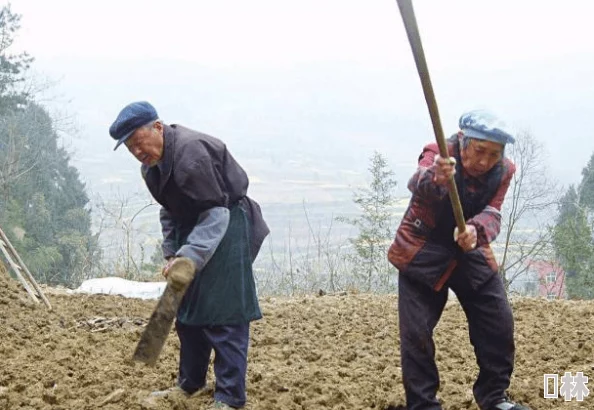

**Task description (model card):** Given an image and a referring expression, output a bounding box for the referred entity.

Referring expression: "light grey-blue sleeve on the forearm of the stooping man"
[176,207,230,272]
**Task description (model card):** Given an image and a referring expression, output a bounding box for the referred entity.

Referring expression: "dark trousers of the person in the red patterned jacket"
[398,271,515,410]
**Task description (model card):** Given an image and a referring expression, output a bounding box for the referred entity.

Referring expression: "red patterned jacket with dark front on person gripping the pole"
[388,135,516,290]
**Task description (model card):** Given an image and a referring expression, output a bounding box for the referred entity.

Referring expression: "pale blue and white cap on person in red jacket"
[458,110,516,145]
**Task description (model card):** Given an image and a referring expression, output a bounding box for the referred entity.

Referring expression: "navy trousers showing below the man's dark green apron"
[175,322,250,407]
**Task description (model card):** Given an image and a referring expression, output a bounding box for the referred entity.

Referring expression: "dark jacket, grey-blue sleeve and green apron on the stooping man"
[142,125,269,326]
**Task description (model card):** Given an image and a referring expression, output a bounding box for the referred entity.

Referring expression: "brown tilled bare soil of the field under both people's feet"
[0,273,594,410]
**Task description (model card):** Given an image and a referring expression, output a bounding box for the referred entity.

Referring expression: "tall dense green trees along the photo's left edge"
[0,6,99,285]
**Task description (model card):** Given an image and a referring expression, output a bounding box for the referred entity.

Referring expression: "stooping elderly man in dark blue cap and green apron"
[109,101,269,409]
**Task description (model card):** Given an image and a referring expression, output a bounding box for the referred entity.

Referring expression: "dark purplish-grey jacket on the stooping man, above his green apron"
[142,125,270,259]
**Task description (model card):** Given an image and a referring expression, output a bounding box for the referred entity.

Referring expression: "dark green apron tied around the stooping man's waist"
[177,205,262,326]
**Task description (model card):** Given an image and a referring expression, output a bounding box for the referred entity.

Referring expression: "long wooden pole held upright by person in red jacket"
[396,0,466,233]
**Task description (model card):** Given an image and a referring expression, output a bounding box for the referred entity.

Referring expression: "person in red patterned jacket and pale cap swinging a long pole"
[388,111,527,410]
